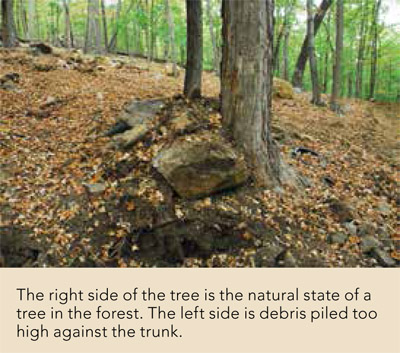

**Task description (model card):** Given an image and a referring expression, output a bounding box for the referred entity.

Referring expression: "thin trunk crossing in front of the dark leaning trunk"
[307,0,322,105]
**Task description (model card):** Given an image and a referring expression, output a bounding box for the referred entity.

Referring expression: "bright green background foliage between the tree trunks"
[16,0,400,101]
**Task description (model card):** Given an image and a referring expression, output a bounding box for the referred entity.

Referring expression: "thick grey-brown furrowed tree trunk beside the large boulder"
[221,0,280,185]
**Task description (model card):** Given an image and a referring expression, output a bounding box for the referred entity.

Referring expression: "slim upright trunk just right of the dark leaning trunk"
[330,0,343,111]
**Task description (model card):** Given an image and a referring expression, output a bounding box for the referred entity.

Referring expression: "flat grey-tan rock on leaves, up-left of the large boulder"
[108,100,164,148]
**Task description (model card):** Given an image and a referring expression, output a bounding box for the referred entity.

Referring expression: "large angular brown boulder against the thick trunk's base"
[153,134,248,198]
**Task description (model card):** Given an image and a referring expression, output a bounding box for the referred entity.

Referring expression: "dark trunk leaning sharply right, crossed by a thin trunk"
[292,0,332,88]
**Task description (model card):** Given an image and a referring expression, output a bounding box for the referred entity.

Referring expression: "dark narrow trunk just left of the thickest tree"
[183,0,203,98]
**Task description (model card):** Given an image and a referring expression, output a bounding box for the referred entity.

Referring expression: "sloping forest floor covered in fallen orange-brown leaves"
[0,49,400,267]
